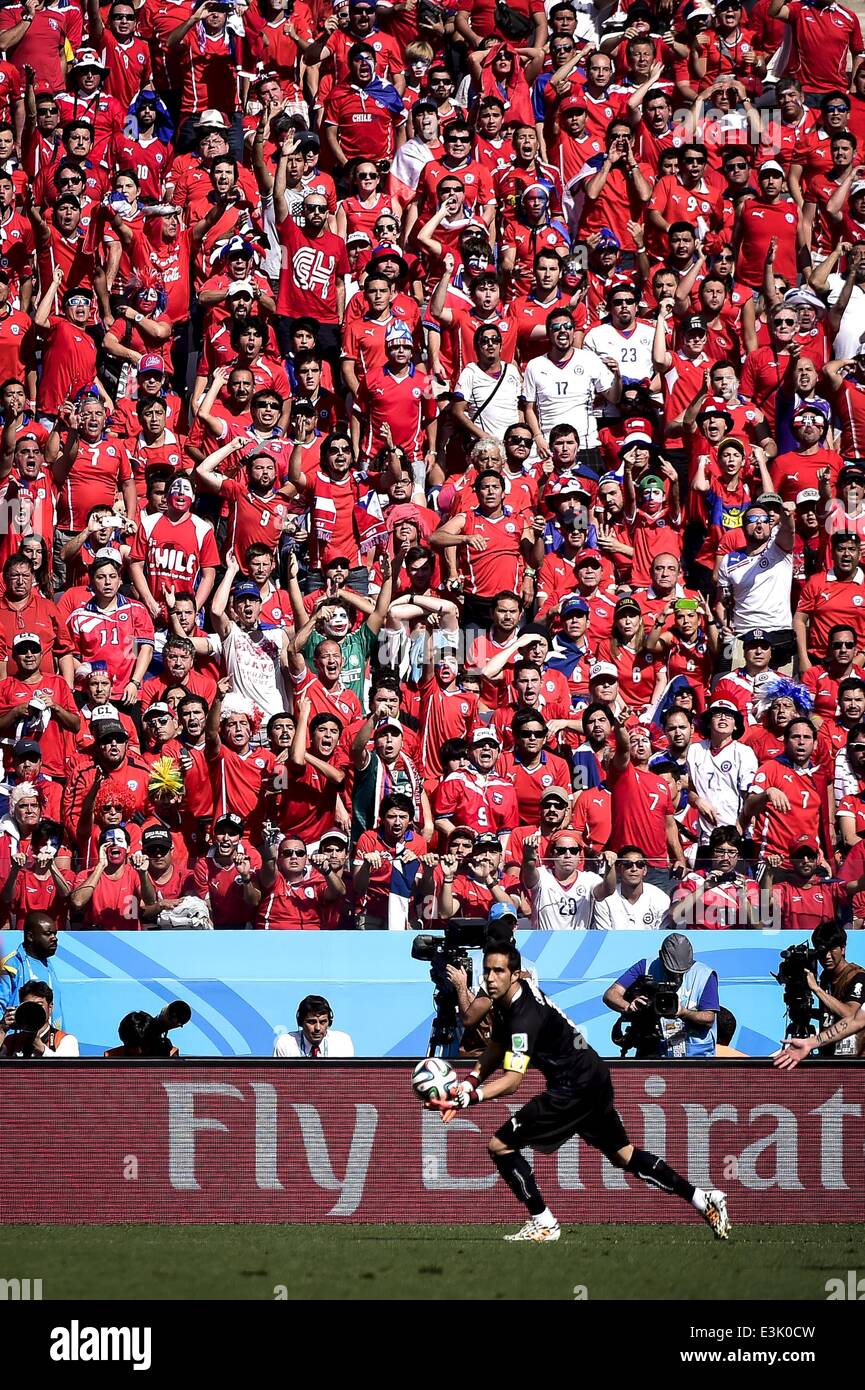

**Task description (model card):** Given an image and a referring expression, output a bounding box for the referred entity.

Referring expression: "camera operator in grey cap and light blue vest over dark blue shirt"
[604,931,720,1058]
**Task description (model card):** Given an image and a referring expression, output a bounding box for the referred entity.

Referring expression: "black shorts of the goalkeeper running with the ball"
[495,1079,630,1156]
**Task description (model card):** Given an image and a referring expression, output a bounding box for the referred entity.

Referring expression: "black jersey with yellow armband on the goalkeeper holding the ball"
[492,980,609,1095]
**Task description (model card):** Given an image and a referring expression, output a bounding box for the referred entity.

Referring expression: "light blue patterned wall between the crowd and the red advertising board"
[3,931,805,1058]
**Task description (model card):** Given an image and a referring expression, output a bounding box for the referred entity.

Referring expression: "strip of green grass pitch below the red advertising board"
[0,1211,862,1301]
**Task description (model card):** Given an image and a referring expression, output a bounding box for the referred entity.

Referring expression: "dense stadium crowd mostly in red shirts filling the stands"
[0,0,865,930]
